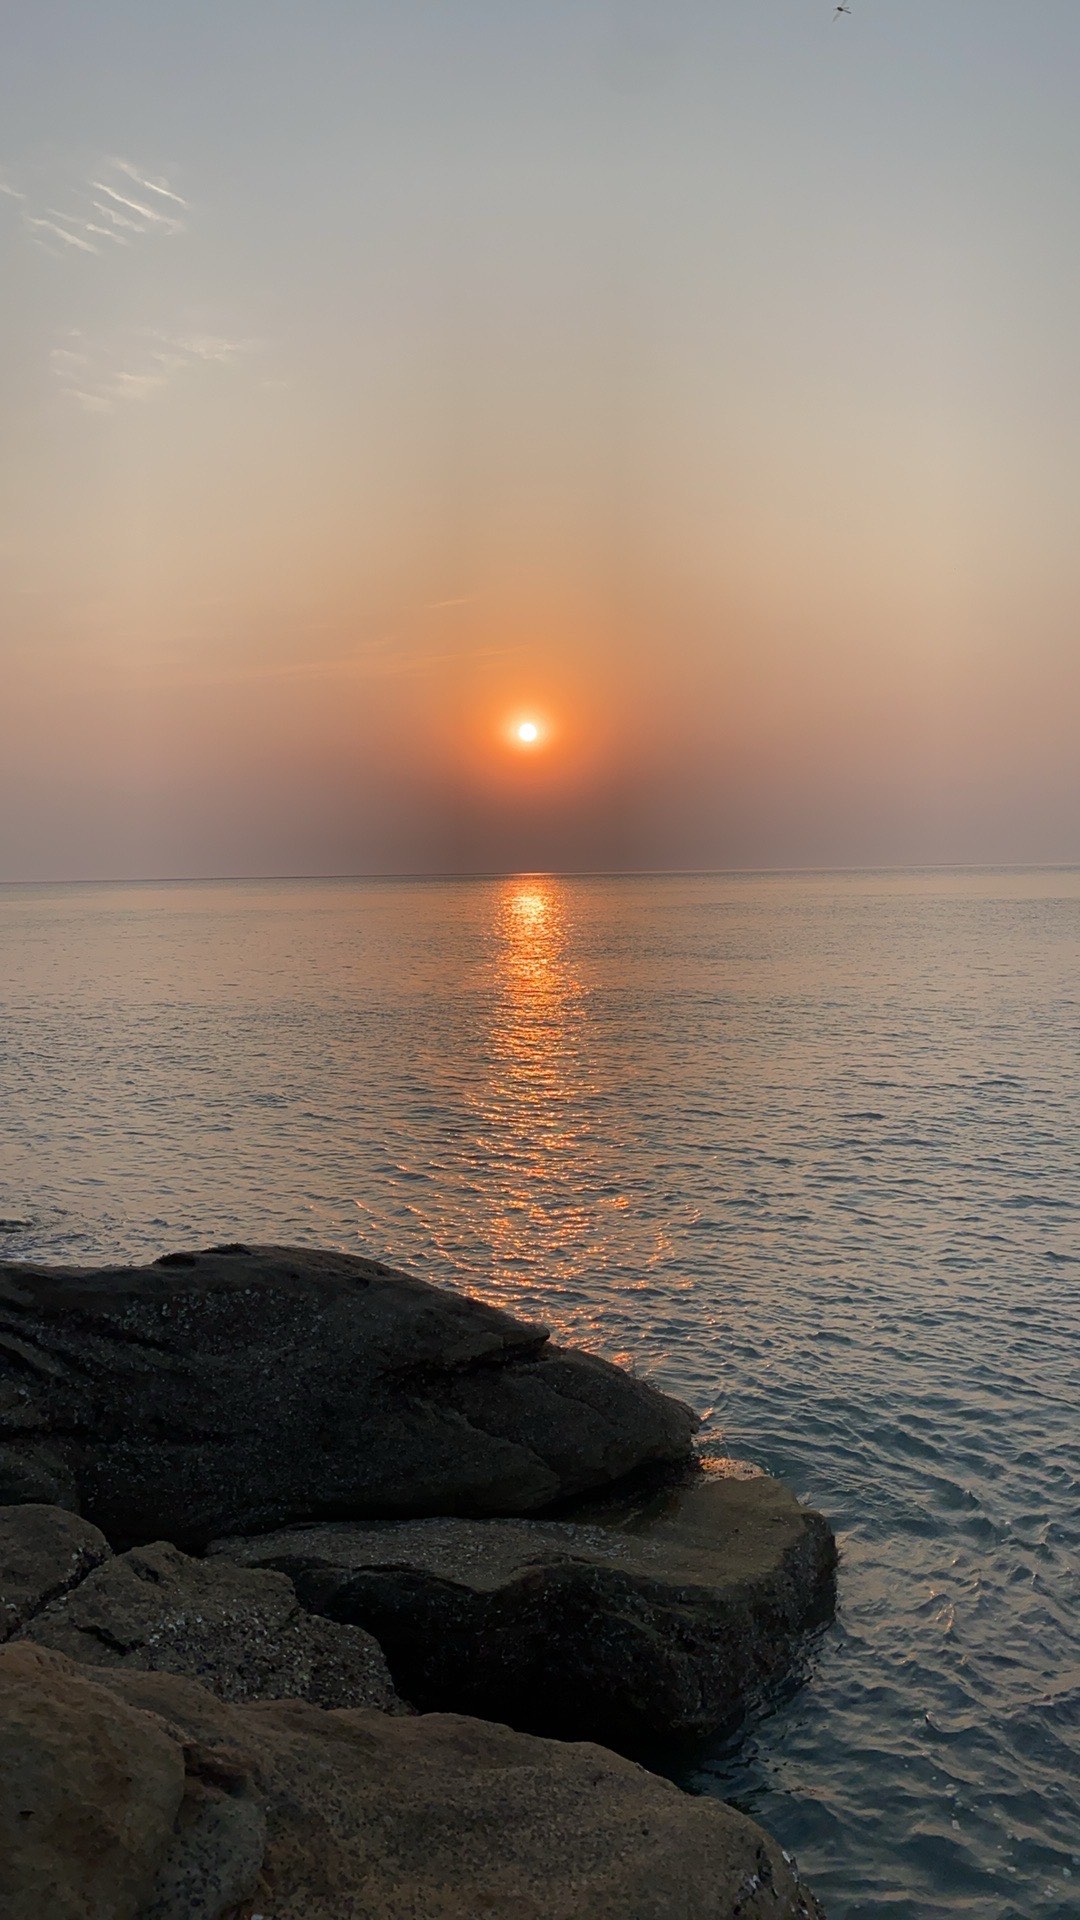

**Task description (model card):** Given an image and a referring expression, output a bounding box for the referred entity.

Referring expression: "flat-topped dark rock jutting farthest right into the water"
[211,1475,836,1751]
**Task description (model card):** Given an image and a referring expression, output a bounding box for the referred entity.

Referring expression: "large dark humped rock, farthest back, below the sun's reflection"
[0,1248,696,1546]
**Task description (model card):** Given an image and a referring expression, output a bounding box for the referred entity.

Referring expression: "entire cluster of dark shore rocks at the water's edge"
[0,1246,836,1920]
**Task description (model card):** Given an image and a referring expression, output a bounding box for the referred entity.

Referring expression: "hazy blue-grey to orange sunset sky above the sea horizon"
[0,0,1080,879]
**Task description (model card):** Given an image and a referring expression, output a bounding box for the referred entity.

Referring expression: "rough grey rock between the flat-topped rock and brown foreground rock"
[15,1509,402,1711]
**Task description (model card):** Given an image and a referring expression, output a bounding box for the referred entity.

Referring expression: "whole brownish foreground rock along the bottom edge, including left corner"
[0,1644,822,1920]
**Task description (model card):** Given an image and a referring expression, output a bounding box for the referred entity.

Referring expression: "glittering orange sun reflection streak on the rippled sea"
[354,874,690,1365]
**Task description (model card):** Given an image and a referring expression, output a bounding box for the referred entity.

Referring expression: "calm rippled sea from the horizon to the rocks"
[0,872,1080,1920]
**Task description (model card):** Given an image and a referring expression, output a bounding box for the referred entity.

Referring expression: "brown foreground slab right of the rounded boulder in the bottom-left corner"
[102,1672,821,1920]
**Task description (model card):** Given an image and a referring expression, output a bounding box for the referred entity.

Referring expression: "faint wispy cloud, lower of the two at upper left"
[50,328,259,413]
